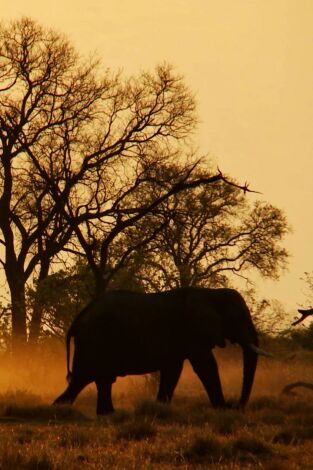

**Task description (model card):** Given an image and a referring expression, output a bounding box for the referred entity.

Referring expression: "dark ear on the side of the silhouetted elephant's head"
[187,306,226,350]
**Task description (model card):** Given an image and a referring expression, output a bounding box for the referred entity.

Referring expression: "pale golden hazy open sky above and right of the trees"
[0,0,313,308]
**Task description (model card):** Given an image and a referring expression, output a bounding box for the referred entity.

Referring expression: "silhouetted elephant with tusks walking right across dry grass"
[54,287,267,415]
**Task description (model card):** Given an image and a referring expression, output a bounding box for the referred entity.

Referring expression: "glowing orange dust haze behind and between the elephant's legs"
[0,343,313,415]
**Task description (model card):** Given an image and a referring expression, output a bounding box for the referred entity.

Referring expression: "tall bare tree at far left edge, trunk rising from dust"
[0,18,119,345]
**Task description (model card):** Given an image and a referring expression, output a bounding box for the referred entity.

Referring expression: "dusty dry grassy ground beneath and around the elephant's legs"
[0,350,313,470]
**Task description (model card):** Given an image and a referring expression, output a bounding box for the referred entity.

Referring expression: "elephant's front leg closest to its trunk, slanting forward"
[189,351,226,408]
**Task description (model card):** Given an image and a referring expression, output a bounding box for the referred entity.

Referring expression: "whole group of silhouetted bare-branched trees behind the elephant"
[0,18,288,349]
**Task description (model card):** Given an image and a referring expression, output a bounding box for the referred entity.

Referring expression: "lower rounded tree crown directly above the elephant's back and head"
[120,167,288,290]
